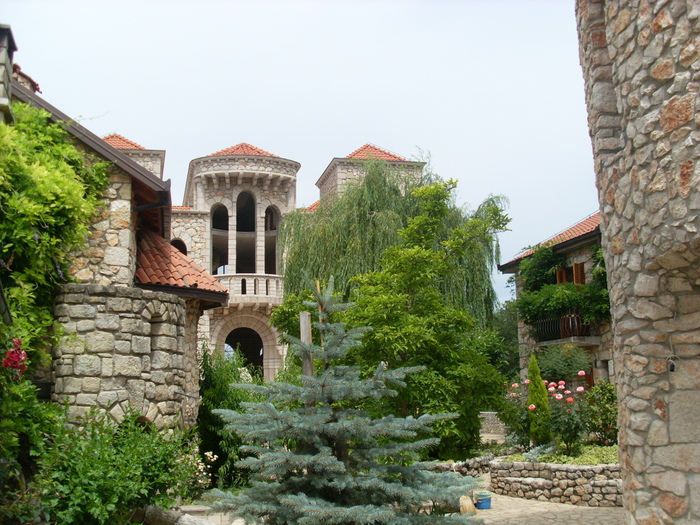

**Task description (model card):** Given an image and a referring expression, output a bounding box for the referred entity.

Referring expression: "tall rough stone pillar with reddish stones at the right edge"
[576,0,700,525]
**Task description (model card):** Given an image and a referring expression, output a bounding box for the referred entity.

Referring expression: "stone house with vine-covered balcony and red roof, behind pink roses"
[498,213,615,383]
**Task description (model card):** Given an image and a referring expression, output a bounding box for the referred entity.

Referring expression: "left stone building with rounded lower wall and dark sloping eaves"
[5,39,228,425]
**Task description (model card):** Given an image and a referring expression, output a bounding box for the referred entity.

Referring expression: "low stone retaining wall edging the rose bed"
[489,461,622,507]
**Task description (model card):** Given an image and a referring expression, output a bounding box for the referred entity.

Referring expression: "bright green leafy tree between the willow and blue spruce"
[347,182,507,458]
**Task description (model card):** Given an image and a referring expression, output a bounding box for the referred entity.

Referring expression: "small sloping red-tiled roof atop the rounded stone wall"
[136,230,226,293]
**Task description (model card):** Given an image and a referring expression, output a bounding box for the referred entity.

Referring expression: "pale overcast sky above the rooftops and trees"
[0,0,598,300]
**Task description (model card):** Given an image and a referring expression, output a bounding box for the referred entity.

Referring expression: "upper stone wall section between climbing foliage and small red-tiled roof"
[70,167,136,286]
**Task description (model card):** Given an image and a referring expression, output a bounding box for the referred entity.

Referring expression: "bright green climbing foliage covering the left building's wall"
[0,104,109,369]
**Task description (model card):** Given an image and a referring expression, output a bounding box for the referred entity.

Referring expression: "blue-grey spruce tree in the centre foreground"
[206,285,482,525]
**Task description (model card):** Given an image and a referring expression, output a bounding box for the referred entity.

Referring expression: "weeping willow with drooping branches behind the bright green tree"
[280,160,505,322]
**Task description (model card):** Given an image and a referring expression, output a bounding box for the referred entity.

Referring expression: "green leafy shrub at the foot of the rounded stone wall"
[25,410,196,525]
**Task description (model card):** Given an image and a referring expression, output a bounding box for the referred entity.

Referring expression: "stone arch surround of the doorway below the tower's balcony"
[211,312,284,381]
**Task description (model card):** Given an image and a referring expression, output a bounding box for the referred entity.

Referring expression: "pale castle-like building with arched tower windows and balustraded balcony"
[172,143,423,380]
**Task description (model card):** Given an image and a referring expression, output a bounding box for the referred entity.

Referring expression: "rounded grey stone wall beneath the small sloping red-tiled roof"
[52,283,199,426]
